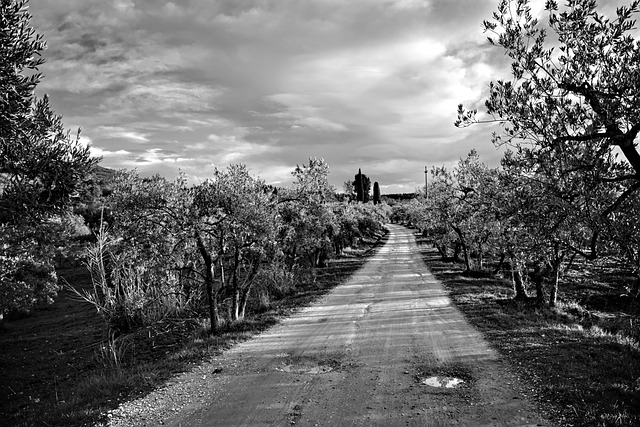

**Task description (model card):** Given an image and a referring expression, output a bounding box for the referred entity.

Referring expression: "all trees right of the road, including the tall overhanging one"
[408,0,640,305]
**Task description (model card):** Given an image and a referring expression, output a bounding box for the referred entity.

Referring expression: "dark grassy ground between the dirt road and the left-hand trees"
[0,238,384,426]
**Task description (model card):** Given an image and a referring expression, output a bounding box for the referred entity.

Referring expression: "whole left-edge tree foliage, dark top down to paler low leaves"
[0,0,97,315]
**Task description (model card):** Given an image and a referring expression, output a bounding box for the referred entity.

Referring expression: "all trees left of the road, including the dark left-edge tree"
[0,0,385,330]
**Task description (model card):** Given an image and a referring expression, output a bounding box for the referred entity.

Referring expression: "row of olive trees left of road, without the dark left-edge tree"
[81,158,386,332]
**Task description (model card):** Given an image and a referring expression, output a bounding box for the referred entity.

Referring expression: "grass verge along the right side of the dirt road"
[418,239,640,426]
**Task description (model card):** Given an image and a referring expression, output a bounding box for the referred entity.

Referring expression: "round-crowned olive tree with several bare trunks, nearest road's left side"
[190,165,278,331]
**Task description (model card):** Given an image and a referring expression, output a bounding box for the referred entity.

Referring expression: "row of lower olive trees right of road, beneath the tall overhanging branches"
[394,151,640,306]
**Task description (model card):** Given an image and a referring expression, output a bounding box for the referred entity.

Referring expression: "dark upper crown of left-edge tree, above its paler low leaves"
[0,0,97,222]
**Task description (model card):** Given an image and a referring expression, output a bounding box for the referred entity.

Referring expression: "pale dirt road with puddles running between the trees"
[111,225,549,426]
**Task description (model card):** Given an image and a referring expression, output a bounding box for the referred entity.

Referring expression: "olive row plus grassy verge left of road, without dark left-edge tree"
[0,153,389,426]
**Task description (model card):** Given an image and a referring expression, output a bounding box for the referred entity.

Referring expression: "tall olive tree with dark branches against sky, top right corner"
[456,0,640,259]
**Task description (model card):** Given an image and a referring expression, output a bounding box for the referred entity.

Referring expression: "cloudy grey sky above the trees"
[29,0,568,193]
